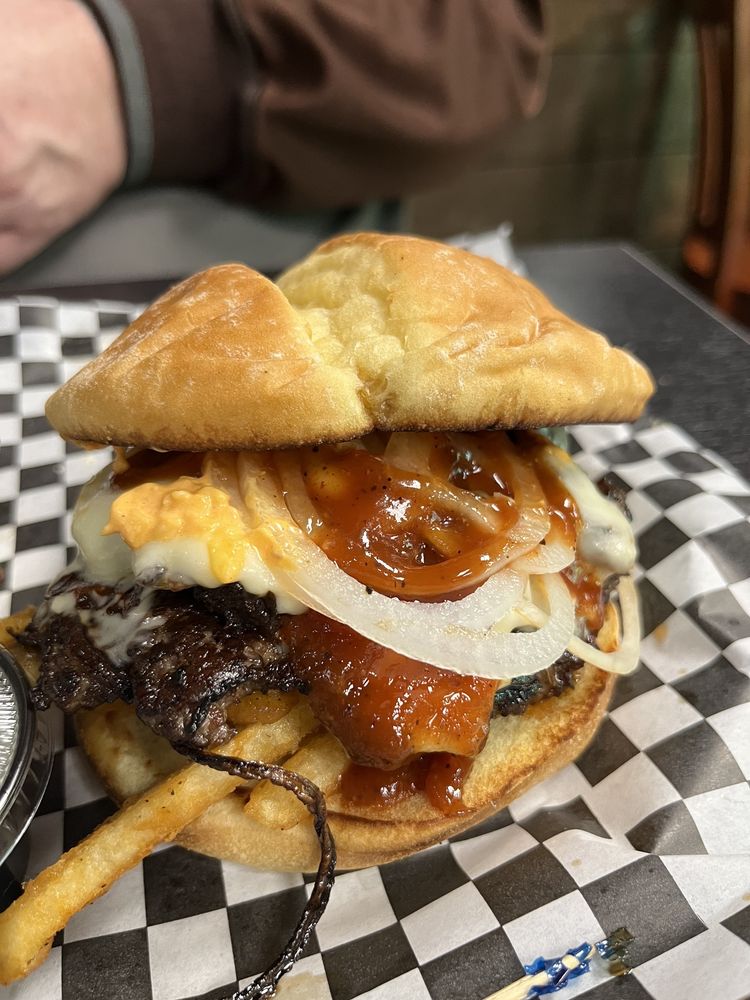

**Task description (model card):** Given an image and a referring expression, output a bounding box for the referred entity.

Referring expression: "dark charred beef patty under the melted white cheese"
[18,573,582,747]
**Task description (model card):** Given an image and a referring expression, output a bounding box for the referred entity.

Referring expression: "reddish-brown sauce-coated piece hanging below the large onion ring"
[282,611,497,815]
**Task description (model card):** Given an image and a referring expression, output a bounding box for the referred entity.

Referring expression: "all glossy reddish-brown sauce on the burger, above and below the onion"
[110,433,616,814]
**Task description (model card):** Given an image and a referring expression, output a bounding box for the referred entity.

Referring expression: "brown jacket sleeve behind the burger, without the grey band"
[116,0,542,208]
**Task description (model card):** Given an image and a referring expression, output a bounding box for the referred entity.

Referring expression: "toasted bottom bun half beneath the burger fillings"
[77,664,614,872]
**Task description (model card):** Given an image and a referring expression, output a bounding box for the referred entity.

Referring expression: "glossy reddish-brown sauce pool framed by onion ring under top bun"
[301,435,518,599]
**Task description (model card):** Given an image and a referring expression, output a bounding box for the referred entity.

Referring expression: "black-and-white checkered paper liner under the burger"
[0,297,750,1000]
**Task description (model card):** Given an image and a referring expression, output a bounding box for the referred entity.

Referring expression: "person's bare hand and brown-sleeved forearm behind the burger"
[0,0,542,273]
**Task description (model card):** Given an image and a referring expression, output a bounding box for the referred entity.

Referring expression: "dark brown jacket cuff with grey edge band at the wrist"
[87,0,240,183]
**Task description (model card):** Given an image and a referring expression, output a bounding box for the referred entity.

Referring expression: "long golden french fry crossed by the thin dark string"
[0,702,317,985]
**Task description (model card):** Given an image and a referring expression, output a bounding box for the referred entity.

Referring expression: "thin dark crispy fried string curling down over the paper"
[175,745,336,1000]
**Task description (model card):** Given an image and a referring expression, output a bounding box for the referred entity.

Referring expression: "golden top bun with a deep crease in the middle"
[47,233,653,451]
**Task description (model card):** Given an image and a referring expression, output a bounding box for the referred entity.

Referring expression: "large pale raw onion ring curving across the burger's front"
[238,454,628,680]
